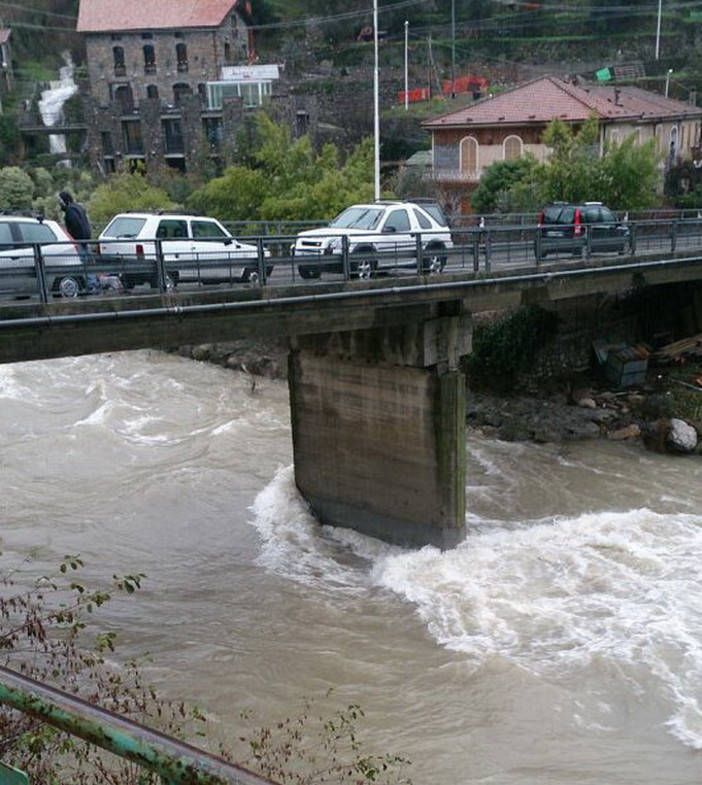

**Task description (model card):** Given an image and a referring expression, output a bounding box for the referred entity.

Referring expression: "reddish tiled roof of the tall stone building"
[77,0,245,33]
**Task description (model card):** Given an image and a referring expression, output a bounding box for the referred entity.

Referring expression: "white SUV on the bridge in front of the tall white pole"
[293,201,453,278]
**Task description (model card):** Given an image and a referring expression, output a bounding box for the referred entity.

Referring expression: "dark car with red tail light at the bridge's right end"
[534,202,631,260]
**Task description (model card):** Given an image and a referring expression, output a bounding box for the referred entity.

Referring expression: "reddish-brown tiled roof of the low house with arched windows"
[423,76,702,129]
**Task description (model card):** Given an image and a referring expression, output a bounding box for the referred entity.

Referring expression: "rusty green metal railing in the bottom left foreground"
[0,667,272,785]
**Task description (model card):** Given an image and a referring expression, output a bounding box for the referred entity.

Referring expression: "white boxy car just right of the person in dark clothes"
[97,212,273,289]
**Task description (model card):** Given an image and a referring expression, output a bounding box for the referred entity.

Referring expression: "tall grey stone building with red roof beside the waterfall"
[77,0,298,173]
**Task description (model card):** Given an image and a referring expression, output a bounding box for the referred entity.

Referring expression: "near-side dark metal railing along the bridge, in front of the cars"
[0,214,702,303]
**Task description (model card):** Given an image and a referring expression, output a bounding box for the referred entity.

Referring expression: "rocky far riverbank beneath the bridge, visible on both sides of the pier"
[173,340,702,453]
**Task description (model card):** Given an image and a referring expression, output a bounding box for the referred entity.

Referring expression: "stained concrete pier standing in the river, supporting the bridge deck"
[288,314,471,548]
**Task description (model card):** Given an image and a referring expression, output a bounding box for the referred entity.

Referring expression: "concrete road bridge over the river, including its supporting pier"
[0,222,702,548]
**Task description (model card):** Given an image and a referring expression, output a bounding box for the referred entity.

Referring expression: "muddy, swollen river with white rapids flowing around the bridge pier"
[0,351,702,785]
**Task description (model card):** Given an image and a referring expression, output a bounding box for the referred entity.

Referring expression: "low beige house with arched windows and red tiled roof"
[423,76,702,211]
